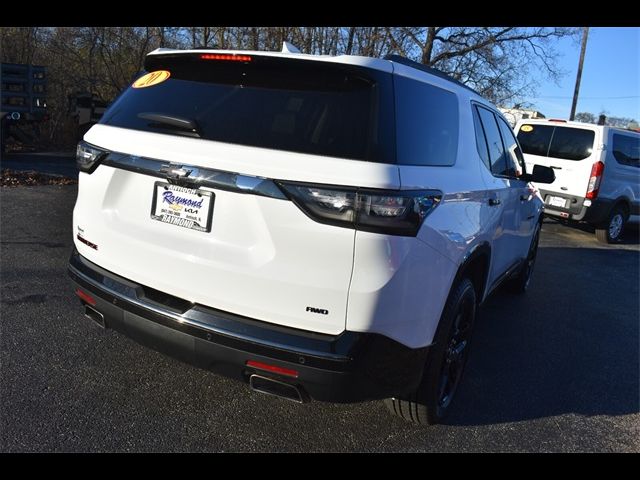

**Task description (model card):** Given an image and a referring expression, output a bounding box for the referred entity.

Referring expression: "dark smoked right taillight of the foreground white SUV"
[278,182,442,237]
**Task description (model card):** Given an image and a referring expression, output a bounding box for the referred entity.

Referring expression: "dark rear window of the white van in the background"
[518,123,595,160]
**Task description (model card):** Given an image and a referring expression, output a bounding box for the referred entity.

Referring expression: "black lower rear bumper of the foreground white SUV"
[68,249,429,402]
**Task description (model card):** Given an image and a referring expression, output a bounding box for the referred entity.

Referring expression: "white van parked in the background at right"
[515,119,640,243]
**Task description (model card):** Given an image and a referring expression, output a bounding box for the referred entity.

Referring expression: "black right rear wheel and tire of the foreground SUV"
[384,278,476,425]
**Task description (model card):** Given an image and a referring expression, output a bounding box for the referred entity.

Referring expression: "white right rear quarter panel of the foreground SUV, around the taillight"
[347,88,495,348]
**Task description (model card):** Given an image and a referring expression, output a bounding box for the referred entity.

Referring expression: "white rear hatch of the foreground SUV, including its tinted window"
[74,52,400,334]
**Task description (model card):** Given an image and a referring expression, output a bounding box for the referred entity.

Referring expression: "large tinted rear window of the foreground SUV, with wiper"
[100,54,395,163]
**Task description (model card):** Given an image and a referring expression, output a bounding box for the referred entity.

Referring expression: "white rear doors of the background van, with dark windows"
[517,122,597,209]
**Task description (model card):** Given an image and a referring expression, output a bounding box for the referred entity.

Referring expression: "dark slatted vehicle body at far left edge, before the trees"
[0,63,48,152]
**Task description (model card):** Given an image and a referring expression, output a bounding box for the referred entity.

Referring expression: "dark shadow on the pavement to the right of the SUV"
[445,248,640,425]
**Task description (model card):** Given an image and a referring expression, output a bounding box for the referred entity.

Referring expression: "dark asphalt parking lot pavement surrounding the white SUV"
[0,186,640,452]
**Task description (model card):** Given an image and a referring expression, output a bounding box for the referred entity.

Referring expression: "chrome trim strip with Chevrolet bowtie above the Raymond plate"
[101,152,287,200]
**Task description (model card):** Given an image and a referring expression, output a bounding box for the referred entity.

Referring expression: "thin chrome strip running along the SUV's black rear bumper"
[68,265,348,361]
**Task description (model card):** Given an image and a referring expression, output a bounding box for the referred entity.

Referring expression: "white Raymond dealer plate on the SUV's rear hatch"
[151,182,215,232]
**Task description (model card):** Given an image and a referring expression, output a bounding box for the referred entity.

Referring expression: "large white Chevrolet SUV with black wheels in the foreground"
[69,49,553,423]
